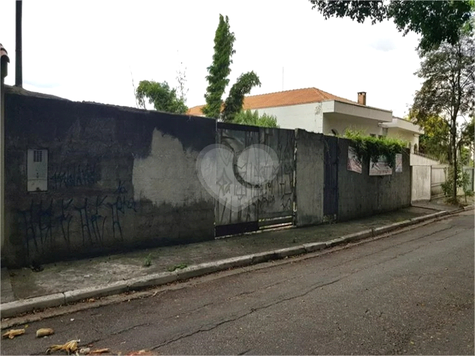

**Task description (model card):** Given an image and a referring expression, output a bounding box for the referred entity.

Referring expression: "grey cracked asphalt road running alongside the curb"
[1,211,474,355]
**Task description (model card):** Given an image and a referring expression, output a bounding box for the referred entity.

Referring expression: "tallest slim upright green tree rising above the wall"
[202,14,236,119]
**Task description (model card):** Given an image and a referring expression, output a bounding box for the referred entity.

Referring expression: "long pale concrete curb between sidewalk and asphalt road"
[0,210,462,318]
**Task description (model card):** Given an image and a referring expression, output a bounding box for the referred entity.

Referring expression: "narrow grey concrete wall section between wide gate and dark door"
[296,130,324,226]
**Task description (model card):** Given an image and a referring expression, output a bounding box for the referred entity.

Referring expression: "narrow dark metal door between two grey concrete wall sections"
[323,136,339,220]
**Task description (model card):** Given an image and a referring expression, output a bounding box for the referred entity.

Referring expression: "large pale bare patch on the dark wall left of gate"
[132,129,208,205]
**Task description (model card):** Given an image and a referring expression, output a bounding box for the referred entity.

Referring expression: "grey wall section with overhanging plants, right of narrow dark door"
[337,139,411,221]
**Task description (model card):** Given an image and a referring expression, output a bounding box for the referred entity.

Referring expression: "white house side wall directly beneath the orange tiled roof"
[252,103,322,133]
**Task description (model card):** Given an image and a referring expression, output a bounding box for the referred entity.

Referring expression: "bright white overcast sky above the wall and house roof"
[0,0,422,117]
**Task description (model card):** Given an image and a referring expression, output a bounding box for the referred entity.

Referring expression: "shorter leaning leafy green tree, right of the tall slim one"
[222,72,261,122]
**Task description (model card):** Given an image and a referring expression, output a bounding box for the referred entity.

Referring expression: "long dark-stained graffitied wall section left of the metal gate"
[2,91,216,266]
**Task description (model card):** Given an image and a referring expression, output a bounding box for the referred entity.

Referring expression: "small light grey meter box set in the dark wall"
[27,149,48,192]
